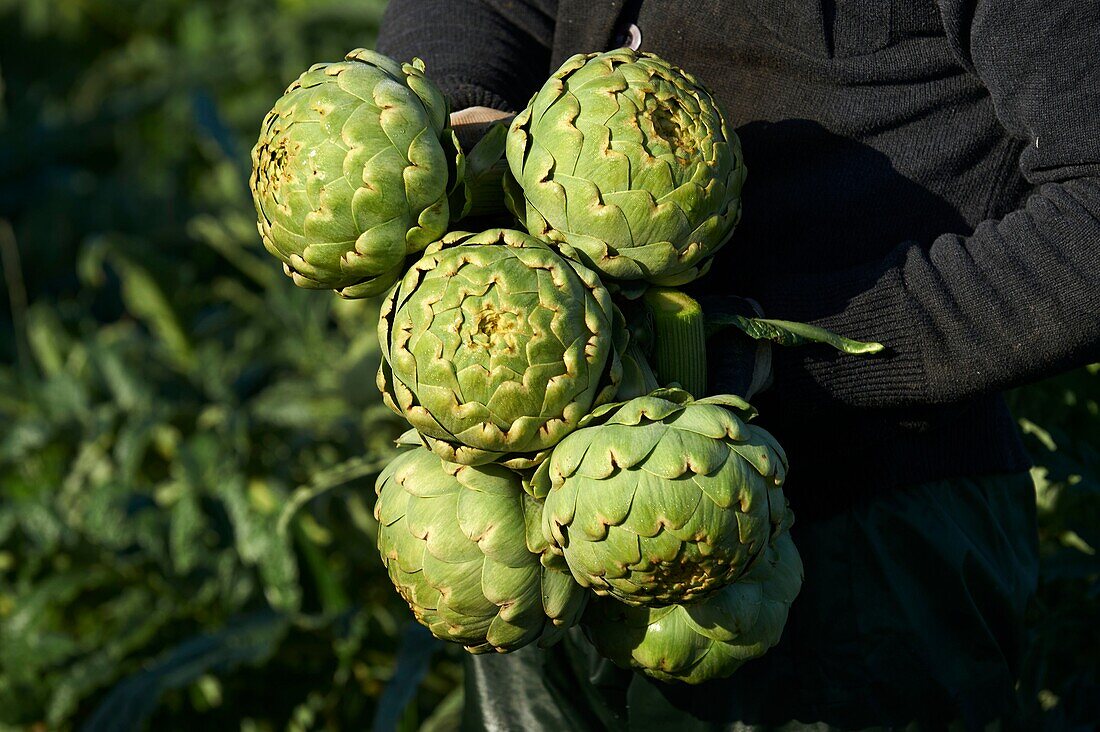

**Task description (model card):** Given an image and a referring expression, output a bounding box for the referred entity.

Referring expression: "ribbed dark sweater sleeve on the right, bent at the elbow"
[758,0,1100,407]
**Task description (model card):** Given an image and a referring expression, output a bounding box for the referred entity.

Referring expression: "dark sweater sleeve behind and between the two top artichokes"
[377,0,557,111]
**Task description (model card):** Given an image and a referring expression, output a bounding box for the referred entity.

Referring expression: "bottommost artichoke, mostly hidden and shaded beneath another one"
[583,532,802,684]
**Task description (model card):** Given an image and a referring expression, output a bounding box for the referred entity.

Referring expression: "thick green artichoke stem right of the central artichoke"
[645,287,706,398]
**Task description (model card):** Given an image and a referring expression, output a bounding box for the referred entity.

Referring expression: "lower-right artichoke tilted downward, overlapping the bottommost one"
[531,389,787,607]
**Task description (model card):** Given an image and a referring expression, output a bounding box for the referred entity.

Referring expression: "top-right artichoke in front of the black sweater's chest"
[507,48,746,286]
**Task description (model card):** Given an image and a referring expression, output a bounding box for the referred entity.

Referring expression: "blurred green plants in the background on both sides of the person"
[0,0,1100,731]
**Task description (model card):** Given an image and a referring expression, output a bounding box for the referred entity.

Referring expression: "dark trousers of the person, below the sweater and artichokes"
[464,473,1038,732]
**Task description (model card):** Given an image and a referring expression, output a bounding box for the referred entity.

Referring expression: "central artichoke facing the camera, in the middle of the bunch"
[378,229,626,469]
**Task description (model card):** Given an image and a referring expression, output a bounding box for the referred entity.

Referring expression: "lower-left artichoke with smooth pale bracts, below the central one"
[374,448,586,653]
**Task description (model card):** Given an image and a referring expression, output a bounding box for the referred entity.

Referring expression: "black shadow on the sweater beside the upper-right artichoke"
[700,119,972,280]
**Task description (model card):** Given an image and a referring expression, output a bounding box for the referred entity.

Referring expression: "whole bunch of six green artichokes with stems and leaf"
[251,50,881,684]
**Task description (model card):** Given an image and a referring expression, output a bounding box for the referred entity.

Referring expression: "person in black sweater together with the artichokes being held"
[251,0,1100,730]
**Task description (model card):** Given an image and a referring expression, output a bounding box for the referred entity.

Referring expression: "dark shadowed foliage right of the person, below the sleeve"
[1011,364,1100,730]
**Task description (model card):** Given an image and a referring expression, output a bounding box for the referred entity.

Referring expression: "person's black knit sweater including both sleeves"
[378,0,1100,513]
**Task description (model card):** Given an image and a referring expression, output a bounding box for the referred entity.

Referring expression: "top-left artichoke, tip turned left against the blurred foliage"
[250,48,451,297]
